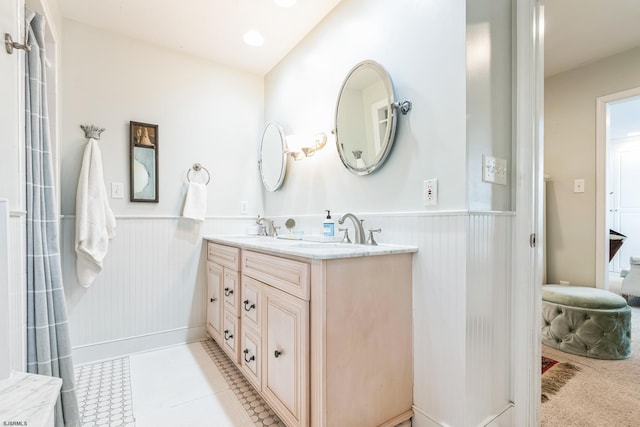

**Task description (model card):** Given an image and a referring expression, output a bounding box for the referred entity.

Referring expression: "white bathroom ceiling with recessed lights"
[59,0,340,75]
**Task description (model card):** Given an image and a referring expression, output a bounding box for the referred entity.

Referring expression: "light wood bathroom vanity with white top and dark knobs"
[205,236,417,427]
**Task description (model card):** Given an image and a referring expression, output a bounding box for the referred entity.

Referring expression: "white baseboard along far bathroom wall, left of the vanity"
[72,325,207,365]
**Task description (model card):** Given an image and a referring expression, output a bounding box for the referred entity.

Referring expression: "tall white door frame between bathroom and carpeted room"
[512,0,544,427]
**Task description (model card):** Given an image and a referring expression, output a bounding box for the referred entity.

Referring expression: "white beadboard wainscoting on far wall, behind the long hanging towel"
[62,216,248,363]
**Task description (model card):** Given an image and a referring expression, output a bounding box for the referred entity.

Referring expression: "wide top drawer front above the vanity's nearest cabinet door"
[242,251,310,301]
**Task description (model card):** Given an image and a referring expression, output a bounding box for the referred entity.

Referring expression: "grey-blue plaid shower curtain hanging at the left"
[25,10,81,427]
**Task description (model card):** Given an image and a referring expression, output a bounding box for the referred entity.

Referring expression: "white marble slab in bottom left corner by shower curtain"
[0,372,62,427]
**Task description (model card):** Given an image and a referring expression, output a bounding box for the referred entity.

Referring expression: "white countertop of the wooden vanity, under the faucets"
[204,236,418,259]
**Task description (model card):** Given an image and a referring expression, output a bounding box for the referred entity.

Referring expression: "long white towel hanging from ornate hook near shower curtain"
[76,138,116,288]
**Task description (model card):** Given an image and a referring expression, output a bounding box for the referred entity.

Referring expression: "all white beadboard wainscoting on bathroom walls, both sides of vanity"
[57,211,513,426]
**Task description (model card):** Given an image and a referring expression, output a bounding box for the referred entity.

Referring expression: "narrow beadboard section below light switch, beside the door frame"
[465,214,512,426]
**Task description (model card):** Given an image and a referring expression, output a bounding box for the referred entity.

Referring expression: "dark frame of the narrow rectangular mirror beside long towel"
[129,121,160,203]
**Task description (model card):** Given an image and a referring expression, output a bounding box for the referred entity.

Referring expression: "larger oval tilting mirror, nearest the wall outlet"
[335,61,395,175]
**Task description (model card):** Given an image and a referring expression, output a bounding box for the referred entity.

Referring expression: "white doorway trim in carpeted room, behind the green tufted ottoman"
[595,87,640,289]
